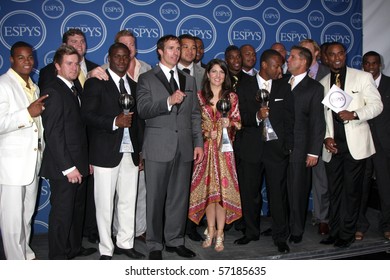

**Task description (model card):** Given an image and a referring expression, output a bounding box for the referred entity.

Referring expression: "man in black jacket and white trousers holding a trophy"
[82,43,144,260]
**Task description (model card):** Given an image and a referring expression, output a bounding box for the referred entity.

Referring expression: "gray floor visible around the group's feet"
[31,208,390,260]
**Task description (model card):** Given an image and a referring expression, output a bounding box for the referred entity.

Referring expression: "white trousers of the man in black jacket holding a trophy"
[93,153,138,256]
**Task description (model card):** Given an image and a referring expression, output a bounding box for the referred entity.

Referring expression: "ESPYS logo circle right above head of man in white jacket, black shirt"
[321,22,354,52]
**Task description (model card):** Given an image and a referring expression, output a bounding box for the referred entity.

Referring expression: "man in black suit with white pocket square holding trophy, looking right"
[235,49,294,253]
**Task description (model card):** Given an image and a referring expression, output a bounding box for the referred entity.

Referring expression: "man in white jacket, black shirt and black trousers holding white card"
[320,42,383,248]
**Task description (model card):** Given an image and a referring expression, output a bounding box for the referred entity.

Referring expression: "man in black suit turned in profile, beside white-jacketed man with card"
[287,46,325,243]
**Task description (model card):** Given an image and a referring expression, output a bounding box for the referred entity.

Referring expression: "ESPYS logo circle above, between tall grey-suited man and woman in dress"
[176,15,217,52]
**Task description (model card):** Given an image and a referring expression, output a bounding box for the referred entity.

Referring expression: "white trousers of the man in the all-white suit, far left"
[0,177,39,260]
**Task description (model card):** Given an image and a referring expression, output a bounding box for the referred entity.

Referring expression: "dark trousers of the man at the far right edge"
[372,144,390,232]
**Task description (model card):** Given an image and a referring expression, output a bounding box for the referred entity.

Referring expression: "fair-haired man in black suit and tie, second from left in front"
[40,46,96,259]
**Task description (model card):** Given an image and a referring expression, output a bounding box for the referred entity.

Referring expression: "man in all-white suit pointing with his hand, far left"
[0,42,47,260]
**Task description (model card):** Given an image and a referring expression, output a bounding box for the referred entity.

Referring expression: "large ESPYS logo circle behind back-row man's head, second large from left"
[61,11,107,52]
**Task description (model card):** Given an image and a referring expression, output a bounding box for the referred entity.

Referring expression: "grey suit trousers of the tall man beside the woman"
[145,155,192,252]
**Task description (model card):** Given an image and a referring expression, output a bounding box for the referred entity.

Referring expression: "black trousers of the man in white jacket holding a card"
[325,152,366,240]
